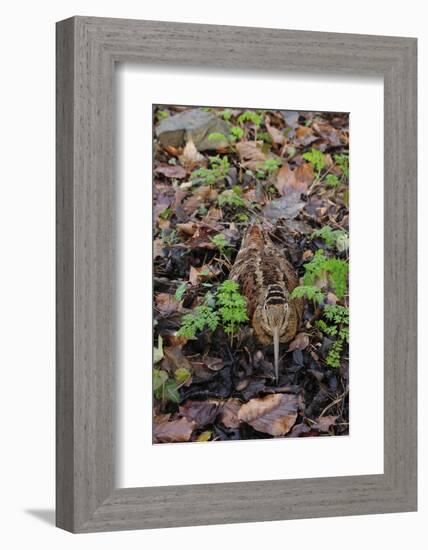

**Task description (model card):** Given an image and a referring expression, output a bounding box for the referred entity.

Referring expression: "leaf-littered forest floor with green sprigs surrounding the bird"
[153,106,349,443]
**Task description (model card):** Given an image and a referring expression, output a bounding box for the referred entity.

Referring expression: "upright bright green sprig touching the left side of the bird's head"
[216,279,248,340]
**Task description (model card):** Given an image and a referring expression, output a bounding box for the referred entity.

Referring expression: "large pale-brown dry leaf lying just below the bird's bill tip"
[238,393,299,436]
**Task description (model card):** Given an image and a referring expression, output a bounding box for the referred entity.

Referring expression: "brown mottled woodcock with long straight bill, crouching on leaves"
[229,224,303,381]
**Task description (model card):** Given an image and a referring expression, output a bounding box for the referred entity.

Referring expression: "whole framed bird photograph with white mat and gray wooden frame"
[57,17,417,533]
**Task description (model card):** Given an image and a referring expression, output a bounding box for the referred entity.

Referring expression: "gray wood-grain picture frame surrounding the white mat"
[57,17,417,533]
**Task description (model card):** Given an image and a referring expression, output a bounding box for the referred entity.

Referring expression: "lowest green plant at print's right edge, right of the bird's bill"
[316,304,349,368]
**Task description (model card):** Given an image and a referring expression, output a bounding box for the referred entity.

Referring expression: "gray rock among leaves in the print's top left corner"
[156,109,230,151]
